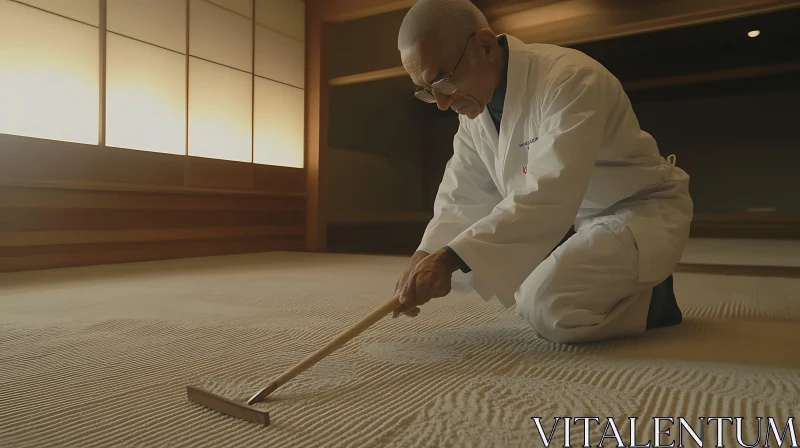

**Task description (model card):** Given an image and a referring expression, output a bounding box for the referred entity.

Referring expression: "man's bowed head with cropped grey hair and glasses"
[397,0,505,119]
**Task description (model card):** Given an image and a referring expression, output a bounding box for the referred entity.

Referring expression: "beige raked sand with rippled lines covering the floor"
[0,252,800,448]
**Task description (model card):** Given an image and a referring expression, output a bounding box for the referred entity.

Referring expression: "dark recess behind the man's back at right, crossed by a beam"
[573,9,800,214]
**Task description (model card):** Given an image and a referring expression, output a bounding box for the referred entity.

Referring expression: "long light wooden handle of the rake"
[247,295,400,404]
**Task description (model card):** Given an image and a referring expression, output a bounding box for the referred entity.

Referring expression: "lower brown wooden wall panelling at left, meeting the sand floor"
[0,186,306,272]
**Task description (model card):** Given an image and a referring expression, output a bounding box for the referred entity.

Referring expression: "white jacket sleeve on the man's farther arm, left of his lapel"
[418,117,503,253]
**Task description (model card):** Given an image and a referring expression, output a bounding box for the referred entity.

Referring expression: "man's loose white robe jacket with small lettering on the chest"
[419,36,693,336]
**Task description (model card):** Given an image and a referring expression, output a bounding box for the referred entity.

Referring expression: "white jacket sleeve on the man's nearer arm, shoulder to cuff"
[450,67,617,307]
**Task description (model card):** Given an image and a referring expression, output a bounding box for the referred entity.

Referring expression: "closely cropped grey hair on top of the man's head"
[397,0,489,51]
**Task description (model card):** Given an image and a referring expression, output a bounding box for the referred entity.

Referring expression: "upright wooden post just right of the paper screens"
[305,4,336,252]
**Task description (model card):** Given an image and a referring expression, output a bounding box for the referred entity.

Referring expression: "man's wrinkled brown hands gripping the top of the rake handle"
[392,249,459,318]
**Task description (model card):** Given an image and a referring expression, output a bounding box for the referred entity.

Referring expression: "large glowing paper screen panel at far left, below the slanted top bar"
[0,0,100,144]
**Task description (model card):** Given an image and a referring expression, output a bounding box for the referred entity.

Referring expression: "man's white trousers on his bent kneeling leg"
[514,217,660,343]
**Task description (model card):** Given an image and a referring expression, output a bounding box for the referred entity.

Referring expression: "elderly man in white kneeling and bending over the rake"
[393,0,693,343]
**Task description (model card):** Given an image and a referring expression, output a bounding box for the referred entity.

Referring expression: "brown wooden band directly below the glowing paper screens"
[0,134,306,194]
